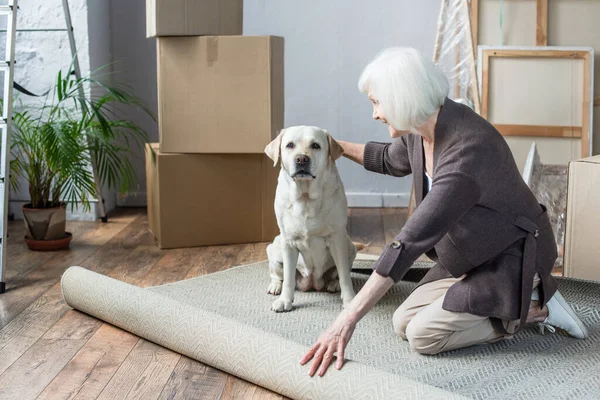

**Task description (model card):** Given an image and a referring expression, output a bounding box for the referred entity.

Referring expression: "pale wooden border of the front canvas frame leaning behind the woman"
[477,45,594,157]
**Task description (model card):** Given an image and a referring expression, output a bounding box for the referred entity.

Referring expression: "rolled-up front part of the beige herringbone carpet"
[61,267,463,399]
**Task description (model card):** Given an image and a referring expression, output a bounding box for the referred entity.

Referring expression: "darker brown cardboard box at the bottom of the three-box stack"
[146,143,279,248]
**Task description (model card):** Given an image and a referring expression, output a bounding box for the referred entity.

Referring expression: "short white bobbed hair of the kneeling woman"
[358,47,450,131]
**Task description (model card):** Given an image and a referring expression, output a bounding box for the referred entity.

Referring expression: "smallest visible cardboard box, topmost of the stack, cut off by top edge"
[146,0,244,37]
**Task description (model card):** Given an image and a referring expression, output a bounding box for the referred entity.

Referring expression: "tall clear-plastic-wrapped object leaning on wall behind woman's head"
[433,0,480,113]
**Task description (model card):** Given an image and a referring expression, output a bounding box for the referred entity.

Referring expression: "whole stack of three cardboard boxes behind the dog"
[146,0,283,248]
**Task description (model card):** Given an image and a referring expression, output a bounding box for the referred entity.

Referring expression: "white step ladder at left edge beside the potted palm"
[0,0,107,293]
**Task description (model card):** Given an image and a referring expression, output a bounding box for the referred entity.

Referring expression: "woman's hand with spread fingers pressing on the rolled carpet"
[300,312,356,376]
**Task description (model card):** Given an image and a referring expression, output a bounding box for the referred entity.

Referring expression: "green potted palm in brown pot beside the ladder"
[10,64,152,250]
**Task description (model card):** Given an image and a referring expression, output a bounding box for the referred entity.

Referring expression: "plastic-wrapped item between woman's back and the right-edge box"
[523,142,568,268]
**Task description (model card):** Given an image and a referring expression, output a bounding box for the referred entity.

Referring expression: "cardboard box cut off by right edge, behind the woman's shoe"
[564,156,600,281]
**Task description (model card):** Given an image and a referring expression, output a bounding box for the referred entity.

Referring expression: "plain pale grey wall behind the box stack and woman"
[111,0,440,207]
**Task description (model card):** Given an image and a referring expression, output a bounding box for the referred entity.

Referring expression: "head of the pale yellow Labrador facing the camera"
[265,126,344,180]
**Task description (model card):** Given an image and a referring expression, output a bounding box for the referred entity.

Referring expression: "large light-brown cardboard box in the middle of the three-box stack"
[157,36,283,153]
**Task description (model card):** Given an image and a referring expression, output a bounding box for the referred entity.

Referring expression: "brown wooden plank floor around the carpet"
[0,208,407,400]
